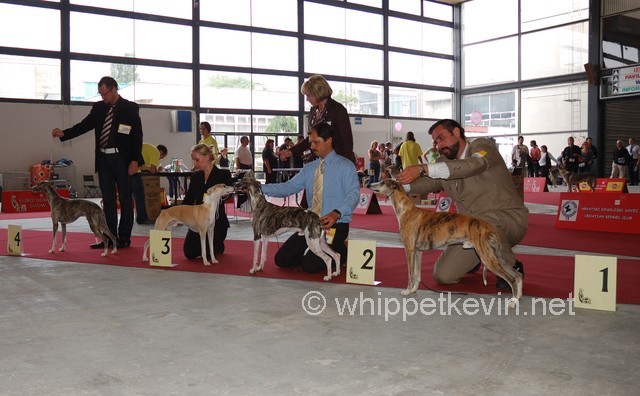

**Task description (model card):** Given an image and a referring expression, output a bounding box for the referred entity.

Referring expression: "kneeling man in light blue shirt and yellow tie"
[262,122,360,273]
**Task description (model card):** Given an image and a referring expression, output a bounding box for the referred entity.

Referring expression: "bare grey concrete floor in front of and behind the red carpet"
[0,186,640,395]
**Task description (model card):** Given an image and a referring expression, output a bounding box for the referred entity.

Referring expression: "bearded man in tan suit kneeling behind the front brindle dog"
[398,119,529,289]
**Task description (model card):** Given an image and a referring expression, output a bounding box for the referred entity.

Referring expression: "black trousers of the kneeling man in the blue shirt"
[275,223,349,273]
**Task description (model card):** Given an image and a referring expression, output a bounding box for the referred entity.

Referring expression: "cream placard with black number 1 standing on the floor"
[573,255,618,311]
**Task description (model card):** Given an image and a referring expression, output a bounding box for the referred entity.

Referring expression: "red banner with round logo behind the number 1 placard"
[556,193,640,234]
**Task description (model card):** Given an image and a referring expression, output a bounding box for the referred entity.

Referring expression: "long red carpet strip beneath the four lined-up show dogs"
[0,229,640,304]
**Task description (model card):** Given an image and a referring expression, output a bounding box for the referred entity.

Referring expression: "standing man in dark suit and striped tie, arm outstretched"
[51,77,143,249]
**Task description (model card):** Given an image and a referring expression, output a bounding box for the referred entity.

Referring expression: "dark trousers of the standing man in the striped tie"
[96,152,133,242]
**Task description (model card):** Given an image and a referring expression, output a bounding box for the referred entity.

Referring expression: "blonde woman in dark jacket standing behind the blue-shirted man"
[280,74,356,165]
